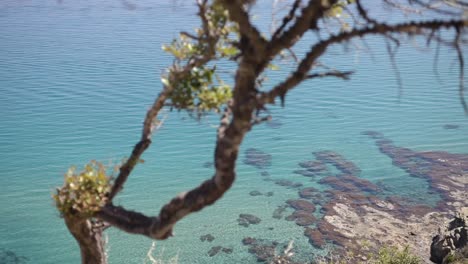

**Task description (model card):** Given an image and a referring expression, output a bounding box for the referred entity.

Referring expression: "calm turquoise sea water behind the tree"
[0,0,468,263]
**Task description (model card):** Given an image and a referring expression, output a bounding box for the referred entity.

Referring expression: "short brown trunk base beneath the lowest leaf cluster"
[64,216,107,264]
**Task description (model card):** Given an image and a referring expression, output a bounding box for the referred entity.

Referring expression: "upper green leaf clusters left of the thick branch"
[161,1,239,116]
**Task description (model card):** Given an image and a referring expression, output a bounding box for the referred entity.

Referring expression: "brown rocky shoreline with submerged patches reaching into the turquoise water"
[239,131,468,263]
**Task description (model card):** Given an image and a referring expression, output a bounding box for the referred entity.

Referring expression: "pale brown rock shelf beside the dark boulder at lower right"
[304,131,468,263]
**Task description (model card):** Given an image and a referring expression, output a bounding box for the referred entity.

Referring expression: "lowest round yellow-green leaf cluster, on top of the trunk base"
[52,161,111,217]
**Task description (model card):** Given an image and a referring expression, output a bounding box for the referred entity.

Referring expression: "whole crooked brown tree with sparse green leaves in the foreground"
[54,0,468,263]
